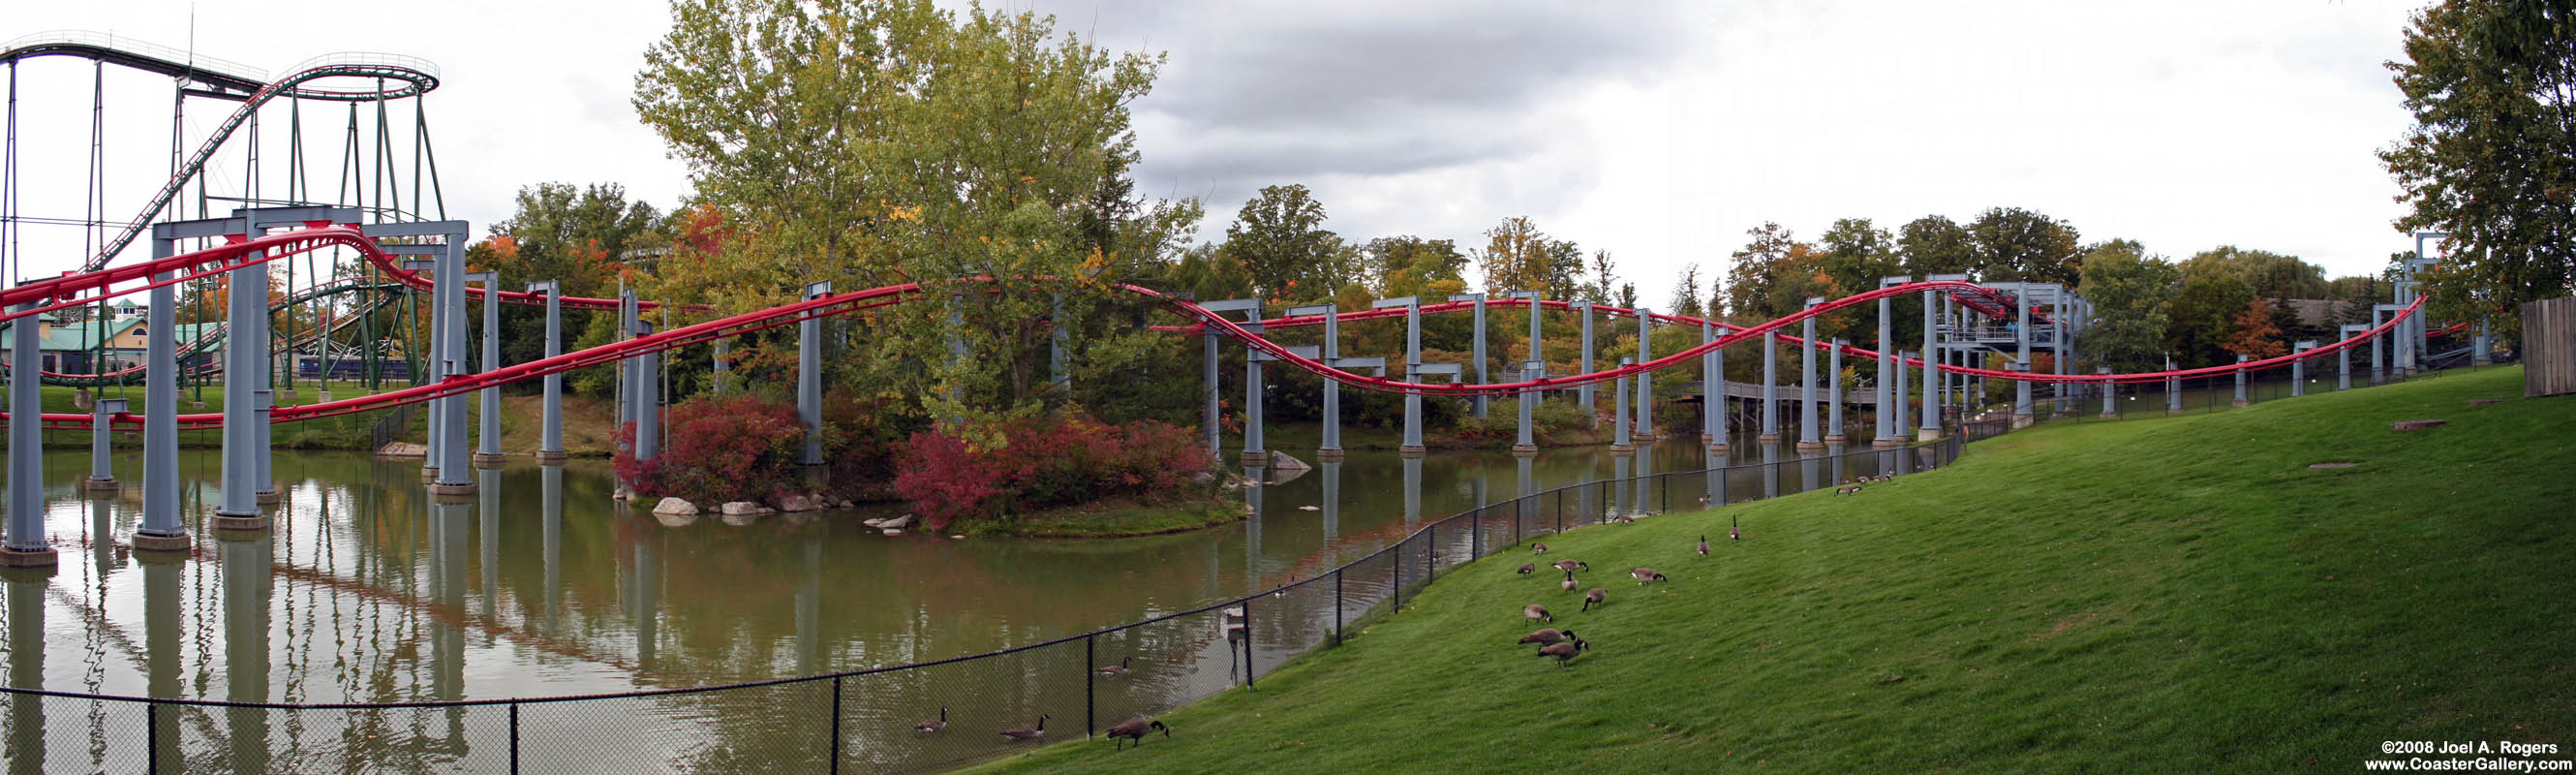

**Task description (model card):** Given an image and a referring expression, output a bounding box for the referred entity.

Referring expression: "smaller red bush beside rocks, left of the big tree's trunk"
[616,394,804,505]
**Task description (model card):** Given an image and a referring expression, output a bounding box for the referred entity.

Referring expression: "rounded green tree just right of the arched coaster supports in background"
[2079,239,2182,371]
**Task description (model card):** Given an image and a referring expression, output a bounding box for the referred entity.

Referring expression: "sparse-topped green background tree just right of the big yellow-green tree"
[1218,183,1358,301]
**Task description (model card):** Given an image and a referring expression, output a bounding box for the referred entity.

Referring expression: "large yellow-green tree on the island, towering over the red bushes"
[633,0,1201,425]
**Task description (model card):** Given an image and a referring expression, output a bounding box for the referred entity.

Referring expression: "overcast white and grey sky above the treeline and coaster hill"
[0,0,2419,304]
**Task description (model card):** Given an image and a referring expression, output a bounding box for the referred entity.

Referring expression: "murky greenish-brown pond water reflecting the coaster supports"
[0,430,1914,772]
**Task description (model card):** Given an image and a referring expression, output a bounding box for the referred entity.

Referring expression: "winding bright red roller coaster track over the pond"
[0,224,2466,430]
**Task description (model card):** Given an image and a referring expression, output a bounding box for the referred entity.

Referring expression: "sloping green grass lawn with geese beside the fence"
[987,368,2576,772]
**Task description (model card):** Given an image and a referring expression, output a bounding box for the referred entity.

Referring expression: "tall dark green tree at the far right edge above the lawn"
[2380,0,2576,329]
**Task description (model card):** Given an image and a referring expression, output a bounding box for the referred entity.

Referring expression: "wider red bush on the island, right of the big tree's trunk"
[894,418,1209,531]
